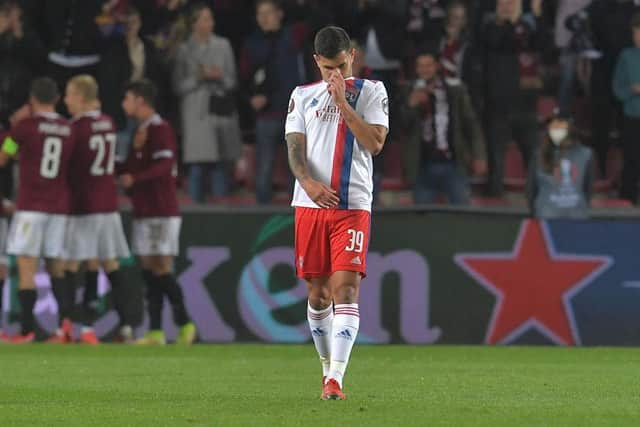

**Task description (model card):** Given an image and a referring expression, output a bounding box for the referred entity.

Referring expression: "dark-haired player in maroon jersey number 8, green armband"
[0,78,75,343]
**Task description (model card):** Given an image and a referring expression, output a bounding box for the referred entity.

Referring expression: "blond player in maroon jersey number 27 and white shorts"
[64,75,132,344]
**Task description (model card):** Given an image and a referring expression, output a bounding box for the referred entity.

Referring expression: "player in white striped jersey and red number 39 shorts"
[285,27,389,400]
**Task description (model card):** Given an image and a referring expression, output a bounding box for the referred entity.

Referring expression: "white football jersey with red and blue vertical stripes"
[285,77,389,211]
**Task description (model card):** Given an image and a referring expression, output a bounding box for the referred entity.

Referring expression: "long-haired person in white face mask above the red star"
[526,113,593,219]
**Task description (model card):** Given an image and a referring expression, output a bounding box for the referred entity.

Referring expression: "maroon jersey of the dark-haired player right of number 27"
[125,115,180,218]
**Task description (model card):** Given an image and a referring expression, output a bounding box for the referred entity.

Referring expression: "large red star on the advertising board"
[455,220,611,345]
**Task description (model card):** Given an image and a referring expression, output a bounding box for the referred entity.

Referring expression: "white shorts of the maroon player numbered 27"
[67,212,131,261]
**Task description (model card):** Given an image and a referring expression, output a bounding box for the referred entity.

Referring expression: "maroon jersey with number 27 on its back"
[71,111,118,215]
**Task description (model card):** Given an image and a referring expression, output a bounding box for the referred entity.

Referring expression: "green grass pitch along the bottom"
[0,344,640,427]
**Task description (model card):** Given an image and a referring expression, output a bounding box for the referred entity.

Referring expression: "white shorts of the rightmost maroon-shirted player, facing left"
[131,217,182,256]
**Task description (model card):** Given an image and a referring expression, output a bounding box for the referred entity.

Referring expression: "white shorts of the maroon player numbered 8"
[7,211,68,258]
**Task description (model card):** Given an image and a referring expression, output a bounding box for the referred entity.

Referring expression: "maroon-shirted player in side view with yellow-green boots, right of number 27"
[120,80,196,344]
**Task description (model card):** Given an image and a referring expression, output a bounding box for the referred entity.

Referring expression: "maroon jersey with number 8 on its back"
[10,113,75,214]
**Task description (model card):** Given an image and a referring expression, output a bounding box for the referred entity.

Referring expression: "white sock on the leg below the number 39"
[329,304,360,388]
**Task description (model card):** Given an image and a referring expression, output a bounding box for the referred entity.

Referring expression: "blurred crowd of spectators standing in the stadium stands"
[0,0,640,211]
